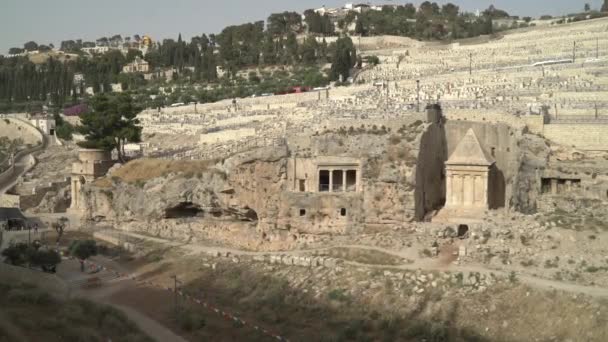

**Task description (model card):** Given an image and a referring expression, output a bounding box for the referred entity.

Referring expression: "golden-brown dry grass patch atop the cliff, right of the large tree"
[95,159,216,187]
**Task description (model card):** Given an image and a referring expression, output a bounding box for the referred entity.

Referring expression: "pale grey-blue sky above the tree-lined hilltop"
[0,0,603,53]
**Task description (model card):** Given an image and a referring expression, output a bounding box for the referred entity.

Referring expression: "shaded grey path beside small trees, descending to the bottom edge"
[57,257,187,342]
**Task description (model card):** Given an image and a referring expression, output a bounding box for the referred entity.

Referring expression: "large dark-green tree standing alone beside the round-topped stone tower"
[78,93,142,162]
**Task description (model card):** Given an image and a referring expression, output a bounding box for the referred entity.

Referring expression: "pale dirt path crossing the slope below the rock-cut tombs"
[108,232,608,298]
